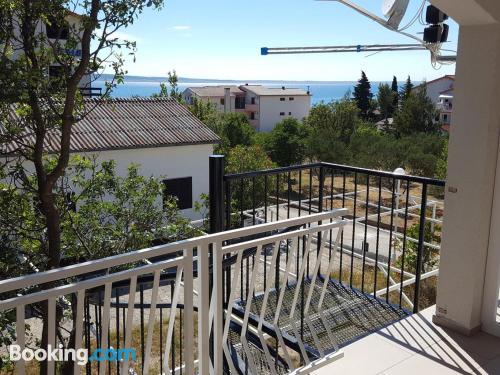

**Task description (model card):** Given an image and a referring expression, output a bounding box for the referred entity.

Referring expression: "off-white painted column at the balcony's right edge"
[434,22,500,333]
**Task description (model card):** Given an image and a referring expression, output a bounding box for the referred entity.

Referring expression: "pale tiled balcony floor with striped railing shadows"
[313,306,500,375]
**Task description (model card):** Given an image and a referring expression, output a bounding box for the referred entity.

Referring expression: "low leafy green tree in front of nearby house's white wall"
[0,156,198,373]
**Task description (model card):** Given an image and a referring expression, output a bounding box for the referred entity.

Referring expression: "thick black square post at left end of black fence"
[209,155,224,233]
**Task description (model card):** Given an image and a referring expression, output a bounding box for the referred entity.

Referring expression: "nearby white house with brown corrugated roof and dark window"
[0,98,219,220]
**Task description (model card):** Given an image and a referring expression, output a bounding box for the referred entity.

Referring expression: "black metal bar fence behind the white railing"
[210,156,445,312]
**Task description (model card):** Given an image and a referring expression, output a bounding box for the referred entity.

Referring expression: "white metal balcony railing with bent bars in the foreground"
[0,209,347,375]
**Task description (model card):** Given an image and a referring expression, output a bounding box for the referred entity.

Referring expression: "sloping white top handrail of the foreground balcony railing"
[0,209,347,293]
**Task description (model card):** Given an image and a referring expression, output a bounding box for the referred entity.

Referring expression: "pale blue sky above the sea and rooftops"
[110,0,458,81]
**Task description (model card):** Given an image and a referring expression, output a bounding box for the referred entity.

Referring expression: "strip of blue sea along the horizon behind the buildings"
[93,76,390,104]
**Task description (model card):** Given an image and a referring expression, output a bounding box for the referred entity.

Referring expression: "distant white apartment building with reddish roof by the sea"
[182,84,311,132]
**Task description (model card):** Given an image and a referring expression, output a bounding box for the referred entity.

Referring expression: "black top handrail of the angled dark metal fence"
[224,162,446,186]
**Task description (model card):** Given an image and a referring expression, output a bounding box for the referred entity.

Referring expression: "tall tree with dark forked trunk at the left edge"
[0,0,163,372]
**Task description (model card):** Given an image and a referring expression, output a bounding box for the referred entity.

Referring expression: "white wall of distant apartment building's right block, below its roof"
[256,95,311,132]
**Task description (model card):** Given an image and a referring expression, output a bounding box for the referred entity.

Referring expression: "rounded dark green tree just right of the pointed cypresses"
[393,89,440,136]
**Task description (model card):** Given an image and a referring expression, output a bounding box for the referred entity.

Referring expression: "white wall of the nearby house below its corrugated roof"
[81,145,213,220]
